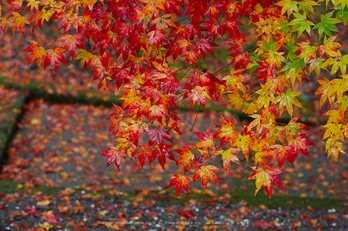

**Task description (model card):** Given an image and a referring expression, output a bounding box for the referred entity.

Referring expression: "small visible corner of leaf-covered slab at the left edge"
[0,85,27,163]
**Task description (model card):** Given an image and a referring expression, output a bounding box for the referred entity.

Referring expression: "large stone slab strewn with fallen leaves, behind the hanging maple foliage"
[0,100,348,199]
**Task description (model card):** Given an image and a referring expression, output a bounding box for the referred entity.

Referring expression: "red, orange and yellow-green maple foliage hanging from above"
[0,0,348,197]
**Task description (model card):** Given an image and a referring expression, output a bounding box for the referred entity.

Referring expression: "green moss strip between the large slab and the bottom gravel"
[0,180,346,211]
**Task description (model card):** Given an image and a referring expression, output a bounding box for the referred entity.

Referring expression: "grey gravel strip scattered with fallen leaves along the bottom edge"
[0,191,348,230]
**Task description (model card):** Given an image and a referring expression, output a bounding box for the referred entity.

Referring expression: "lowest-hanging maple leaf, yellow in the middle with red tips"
[248,164,284,199]
